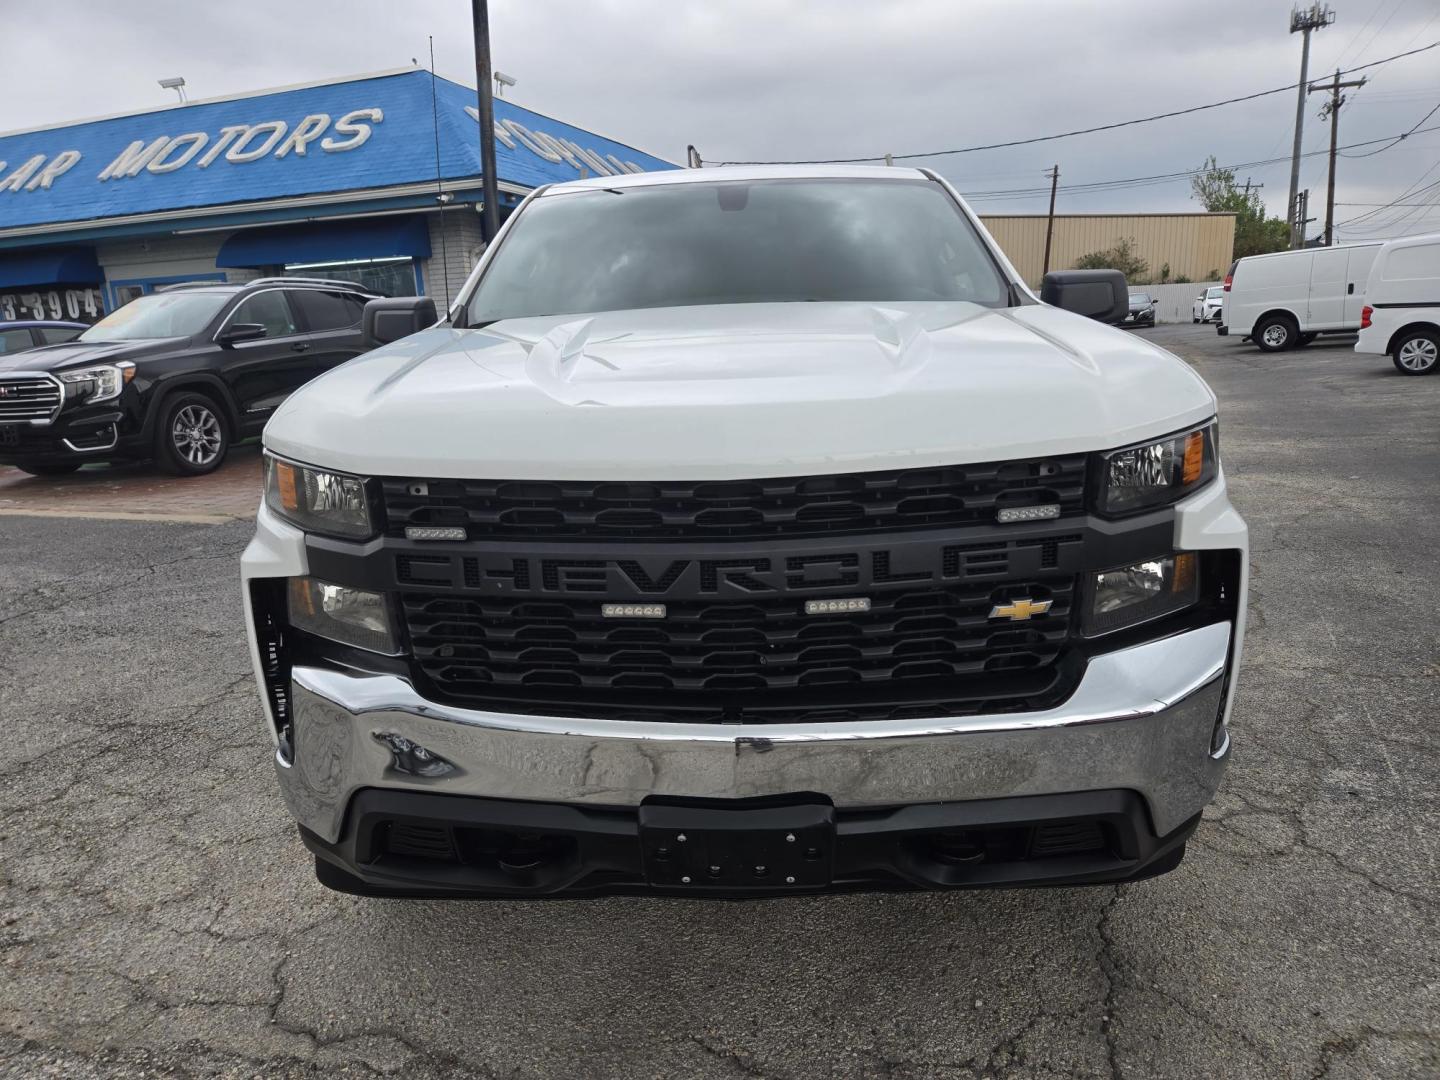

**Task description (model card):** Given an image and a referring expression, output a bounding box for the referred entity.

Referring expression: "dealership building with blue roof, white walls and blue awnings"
[0,68,675,323]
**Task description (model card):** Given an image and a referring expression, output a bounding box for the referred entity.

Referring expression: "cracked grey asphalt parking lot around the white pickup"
[0,324,1440,1079]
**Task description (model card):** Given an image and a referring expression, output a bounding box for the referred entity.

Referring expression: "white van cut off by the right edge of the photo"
[1355,233,1440,374]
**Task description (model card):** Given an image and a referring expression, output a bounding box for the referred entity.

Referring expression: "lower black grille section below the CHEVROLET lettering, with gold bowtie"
[400,575,1073,723]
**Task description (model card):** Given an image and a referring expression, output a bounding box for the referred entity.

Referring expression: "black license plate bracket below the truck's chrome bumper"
[639,802,835,890]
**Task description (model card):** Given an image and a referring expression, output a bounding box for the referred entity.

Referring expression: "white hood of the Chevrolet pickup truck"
[265,302,1215,480]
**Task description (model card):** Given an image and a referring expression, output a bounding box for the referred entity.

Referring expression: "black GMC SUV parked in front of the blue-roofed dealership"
[0,278,374,477]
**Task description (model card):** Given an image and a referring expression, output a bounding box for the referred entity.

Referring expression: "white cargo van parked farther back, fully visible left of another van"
[1217,240,1380,353]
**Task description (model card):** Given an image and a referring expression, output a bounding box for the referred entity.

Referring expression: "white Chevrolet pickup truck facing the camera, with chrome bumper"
[242,167,1247,897]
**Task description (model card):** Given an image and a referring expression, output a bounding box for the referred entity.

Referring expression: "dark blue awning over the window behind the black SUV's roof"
[215,215,431,268]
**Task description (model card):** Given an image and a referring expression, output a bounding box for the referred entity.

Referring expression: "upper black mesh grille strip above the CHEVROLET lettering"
[382,454,1086,541]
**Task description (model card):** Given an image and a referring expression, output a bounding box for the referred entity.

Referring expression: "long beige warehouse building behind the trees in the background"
[981,213,1236,287]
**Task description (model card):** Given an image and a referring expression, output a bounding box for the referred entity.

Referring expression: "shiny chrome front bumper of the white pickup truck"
[276,622,1236,842]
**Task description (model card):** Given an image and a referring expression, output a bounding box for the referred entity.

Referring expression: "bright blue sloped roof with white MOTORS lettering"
[0,71,674,236]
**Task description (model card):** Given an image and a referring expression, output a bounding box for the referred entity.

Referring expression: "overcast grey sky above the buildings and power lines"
[0,0,1440,239]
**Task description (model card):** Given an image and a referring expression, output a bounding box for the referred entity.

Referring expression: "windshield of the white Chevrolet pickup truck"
[467,180,1009,325]
